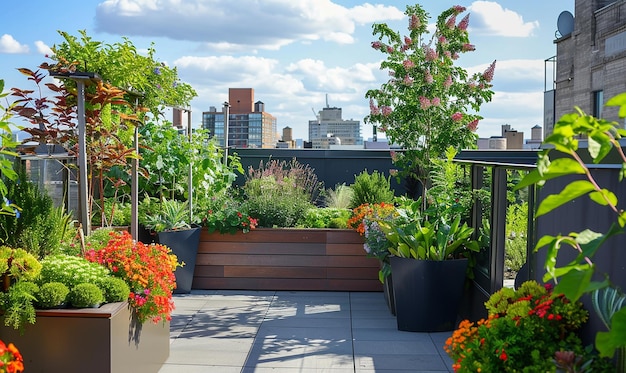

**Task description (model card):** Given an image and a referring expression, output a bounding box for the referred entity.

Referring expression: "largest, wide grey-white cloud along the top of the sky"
[96,0,403,51]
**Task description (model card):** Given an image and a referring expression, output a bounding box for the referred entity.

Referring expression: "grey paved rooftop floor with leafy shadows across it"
[160,291,452,373]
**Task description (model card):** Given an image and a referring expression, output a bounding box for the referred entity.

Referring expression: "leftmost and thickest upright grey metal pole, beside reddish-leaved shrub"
[75,79,91,236]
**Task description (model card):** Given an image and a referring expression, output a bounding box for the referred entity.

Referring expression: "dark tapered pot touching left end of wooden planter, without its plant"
[158,228,201,294]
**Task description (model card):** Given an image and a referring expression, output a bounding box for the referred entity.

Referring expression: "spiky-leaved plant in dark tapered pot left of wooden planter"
[146,198,200,293]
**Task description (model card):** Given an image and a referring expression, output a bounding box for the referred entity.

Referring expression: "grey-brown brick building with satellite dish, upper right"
[544,0,626,136]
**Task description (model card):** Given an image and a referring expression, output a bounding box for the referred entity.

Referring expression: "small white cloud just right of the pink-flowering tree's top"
[468,1,539,37]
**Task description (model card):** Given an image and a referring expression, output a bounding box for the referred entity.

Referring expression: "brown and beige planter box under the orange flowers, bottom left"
[0,302,170,373]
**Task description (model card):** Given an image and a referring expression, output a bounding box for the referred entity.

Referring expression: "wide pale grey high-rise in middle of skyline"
[309,105,363,149]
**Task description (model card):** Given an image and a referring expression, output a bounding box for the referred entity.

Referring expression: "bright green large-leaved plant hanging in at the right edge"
[516,93,626,360]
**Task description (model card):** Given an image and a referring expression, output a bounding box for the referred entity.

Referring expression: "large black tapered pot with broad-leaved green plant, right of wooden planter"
[379,198,479,332]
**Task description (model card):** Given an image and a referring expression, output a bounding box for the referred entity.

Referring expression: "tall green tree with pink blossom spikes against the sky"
[365,5,495,193]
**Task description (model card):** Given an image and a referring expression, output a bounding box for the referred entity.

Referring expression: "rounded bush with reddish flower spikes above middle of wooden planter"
[243,159,322,227]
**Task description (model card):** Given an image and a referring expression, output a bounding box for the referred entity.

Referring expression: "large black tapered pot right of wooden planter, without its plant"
[391,257,467,332]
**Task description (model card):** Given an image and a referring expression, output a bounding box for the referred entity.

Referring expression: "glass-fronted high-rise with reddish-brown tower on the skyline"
[202,88,278,148]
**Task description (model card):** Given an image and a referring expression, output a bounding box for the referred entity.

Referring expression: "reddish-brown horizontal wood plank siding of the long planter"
[193,228,383,291]
